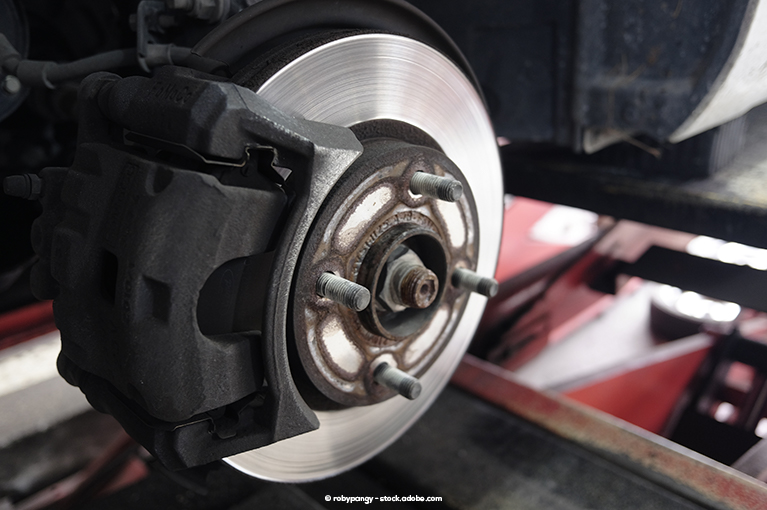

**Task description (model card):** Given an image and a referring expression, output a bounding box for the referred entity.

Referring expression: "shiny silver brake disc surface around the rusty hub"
[225,33,503,482]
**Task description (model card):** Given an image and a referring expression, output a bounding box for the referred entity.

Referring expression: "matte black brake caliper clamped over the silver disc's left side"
[33,66,361,468]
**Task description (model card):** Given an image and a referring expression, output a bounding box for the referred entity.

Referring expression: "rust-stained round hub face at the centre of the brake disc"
[293,140,478,406]
